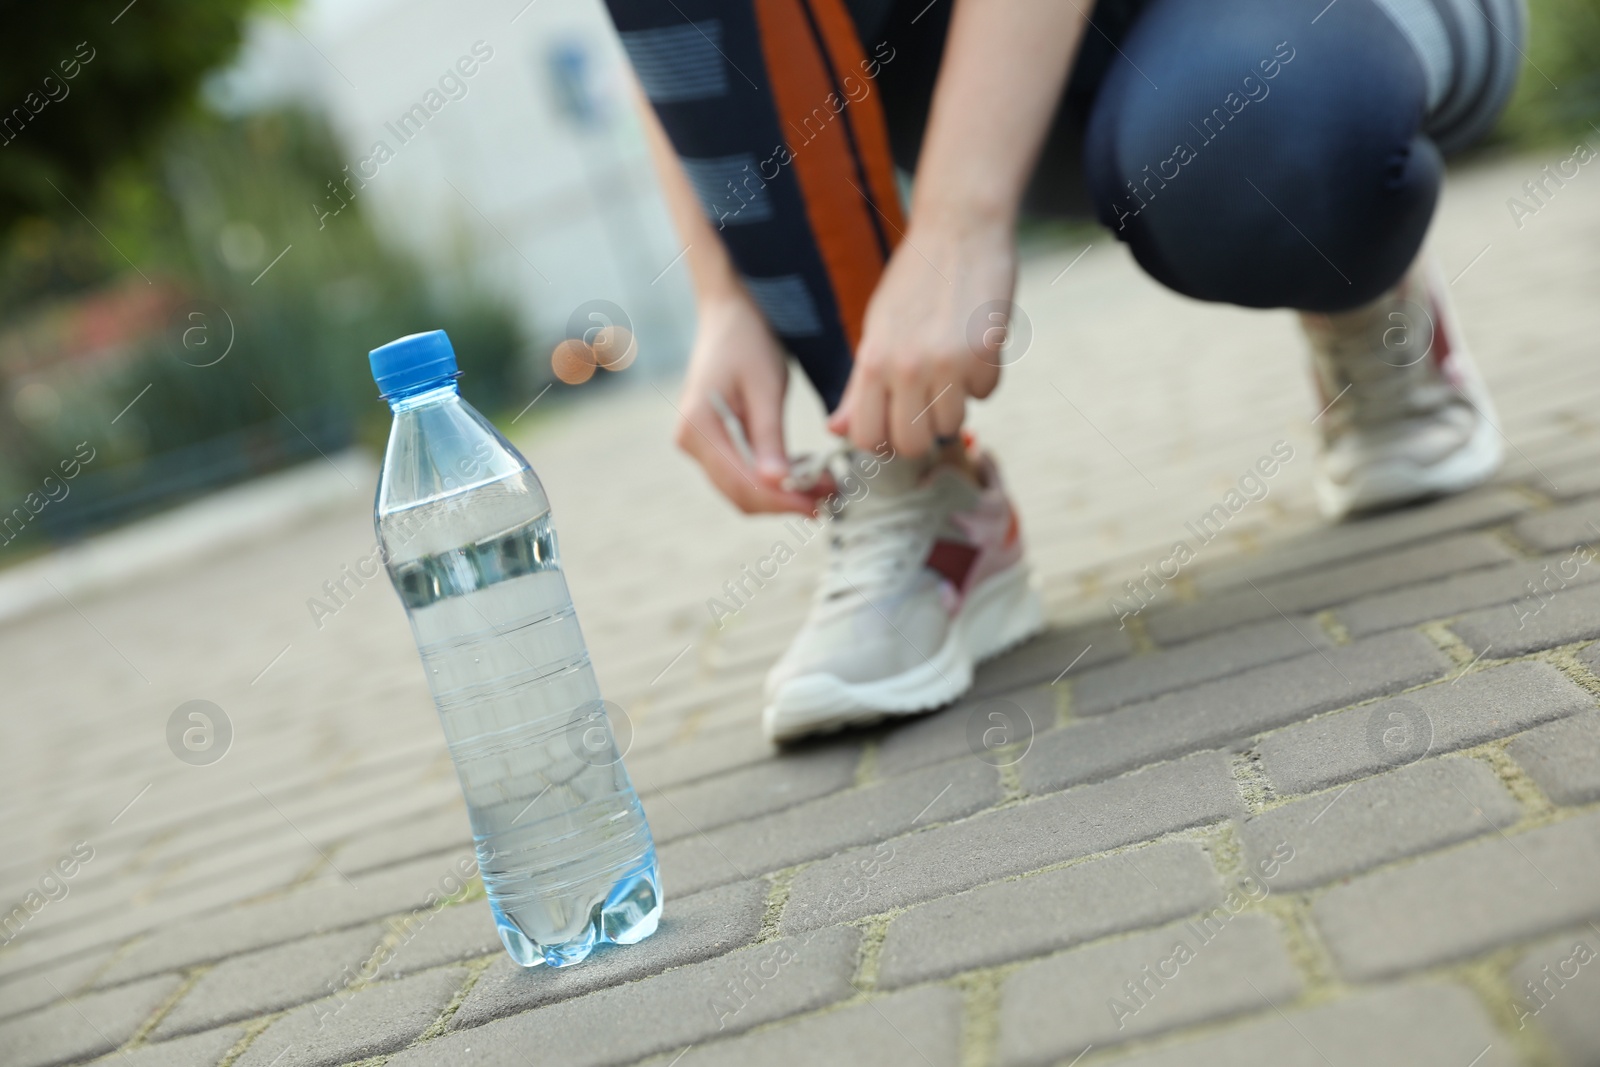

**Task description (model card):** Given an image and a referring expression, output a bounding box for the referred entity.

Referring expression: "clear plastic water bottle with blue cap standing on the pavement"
[370,330,661,966]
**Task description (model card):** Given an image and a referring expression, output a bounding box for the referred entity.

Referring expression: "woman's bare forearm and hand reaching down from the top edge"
[829,0,1088,456]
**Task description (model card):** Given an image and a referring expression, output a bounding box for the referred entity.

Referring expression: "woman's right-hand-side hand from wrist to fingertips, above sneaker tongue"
[827,219,1016,456]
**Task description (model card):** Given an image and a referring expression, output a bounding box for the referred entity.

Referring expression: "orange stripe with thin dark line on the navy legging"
[755,0,906,349]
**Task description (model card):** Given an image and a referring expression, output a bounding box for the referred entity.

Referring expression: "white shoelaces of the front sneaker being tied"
[792,446,939,601]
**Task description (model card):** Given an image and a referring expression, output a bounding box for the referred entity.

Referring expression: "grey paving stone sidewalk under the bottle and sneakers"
[9,155,1600,1067]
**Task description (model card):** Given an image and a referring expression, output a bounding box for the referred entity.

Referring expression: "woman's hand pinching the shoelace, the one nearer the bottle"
[677,290,816,515]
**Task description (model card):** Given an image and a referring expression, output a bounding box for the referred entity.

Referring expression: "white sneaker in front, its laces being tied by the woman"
[762,441,1045,741]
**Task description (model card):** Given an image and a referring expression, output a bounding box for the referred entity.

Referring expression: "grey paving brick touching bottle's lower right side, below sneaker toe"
[640,745,861,843]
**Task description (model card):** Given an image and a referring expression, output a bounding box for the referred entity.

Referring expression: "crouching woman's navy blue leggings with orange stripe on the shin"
[608,0,1442,408]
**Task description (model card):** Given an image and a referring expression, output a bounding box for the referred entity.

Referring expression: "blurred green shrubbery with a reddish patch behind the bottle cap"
[0,110,522,547]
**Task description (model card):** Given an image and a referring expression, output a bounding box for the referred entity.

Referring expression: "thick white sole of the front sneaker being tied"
[762,563,1045,742]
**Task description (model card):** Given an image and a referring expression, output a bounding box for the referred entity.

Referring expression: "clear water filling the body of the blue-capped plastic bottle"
[379,489,661,966]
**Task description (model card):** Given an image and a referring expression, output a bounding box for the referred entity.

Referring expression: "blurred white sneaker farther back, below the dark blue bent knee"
[1301,255,1504,518]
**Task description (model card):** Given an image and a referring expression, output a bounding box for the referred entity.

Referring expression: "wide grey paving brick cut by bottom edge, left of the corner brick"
[1085,982,1520,1067]
